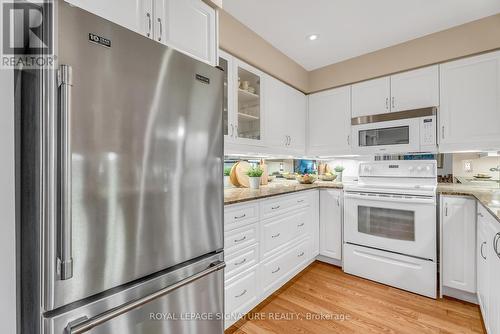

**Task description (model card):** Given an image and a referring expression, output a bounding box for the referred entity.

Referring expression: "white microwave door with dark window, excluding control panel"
[352,118,420,154]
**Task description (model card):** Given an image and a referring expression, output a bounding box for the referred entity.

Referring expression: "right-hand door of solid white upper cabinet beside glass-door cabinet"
[288,86,307,155]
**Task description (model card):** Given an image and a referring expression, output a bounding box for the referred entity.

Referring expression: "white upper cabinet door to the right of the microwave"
[439,51,500,151]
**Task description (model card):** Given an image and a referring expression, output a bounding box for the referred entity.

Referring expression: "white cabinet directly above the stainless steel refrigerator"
[66,0,218,66]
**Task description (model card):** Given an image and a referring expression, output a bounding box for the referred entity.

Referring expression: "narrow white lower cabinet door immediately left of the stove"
[319,189,342,260]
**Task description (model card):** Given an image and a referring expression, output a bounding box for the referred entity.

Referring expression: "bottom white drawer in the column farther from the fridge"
[261,238,311,291]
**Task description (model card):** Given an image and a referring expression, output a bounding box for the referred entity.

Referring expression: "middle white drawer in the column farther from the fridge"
[260,210,310,257]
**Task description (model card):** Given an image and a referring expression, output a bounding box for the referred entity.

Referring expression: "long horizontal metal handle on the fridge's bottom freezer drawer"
[64,261,226,334]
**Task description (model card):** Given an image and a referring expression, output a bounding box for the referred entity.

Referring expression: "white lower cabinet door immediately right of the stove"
[441,197,476,293]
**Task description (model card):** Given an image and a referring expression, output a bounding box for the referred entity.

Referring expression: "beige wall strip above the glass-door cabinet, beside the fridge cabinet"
[219,10,309,92]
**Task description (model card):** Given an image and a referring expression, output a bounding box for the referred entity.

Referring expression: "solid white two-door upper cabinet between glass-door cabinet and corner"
[265,75,307,155]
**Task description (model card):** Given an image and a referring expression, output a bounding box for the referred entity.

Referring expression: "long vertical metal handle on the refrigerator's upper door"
[57,65,73,280]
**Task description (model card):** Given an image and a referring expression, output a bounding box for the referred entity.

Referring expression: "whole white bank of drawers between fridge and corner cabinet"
[224,190,319,328]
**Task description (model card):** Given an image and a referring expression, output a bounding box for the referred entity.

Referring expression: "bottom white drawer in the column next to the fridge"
[224,266,258,320]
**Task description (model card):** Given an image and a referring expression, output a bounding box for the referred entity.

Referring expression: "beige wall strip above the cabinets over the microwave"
[309,14,500,92]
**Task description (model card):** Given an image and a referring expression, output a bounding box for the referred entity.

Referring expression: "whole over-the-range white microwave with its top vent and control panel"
[351,107,437,154]
